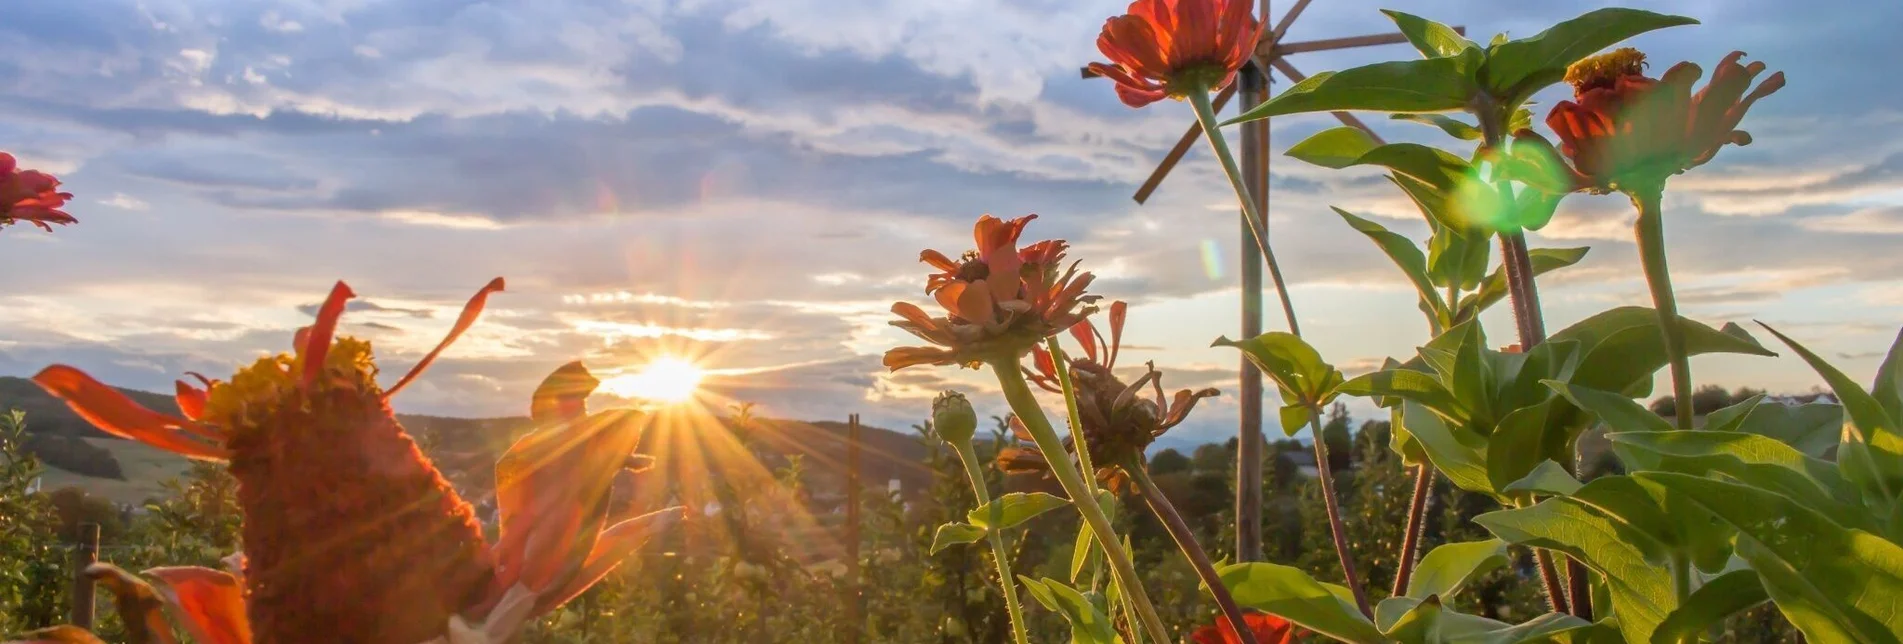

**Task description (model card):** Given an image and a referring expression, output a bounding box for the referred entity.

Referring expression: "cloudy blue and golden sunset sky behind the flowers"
[0,0,1903,442]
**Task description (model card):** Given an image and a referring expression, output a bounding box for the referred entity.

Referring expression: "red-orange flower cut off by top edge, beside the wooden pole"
[1090,0,1262,107]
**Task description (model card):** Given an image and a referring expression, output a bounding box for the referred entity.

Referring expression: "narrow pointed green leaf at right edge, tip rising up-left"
[1764,326,1903,507]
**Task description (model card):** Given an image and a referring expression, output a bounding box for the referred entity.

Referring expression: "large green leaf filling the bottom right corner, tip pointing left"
[1637,473,1903,642]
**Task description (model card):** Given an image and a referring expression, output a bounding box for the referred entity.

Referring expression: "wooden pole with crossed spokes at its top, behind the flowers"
[1083,0,1467,562]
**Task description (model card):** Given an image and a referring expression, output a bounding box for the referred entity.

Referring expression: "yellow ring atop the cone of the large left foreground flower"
[204,337,381,431]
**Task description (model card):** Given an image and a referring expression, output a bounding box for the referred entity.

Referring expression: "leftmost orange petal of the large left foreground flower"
[32,364,230,461]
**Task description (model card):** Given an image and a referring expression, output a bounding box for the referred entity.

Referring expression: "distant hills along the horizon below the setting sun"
[0,377,931,503]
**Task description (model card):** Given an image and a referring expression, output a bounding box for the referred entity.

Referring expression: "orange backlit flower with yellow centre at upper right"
[1517,48,1785,194]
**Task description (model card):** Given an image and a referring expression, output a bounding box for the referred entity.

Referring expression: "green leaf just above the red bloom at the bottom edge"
[1218,562,1387,644]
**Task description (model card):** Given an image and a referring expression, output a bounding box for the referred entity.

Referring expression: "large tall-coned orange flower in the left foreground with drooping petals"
[34,278,677,644]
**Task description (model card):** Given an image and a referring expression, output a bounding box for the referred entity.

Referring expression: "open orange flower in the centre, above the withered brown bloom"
[885,215,1096,372]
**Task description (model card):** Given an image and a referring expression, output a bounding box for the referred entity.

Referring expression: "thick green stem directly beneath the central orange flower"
[991,356,1170,642]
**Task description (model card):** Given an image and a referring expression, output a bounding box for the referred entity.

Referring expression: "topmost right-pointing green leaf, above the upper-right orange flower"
[1481,8,1697,107]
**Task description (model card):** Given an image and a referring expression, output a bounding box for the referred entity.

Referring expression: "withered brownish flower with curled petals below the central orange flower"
[997,301,1220,490]
